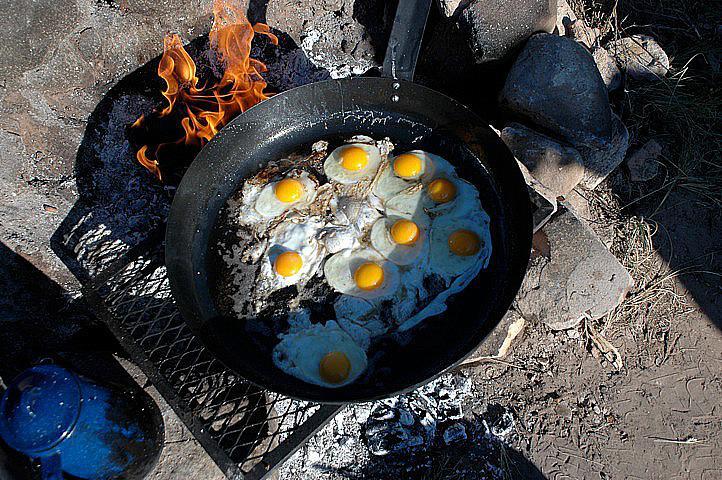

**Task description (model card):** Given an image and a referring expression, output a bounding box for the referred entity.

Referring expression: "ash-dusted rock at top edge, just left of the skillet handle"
[266,0,393,78]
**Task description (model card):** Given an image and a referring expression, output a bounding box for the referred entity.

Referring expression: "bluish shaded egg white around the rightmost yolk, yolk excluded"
[429,210,491,283]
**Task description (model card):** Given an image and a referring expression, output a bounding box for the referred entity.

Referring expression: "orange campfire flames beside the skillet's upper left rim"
[131,0,278,181]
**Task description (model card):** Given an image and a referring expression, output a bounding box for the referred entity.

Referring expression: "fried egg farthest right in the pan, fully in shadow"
[429,209,491,283]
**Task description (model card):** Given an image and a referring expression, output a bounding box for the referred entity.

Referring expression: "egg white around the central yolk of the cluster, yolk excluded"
[371,214,429,265]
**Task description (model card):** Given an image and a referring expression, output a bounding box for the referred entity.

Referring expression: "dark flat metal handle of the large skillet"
[383,0,431,81]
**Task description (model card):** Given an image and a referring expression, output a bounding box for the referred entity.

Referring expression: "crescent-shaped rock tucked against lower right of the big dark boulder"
[577,114,629,189]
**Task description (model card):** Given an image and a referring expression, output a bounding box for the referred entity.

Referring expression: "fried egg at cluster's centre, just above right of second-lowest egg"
[370,214,429,265]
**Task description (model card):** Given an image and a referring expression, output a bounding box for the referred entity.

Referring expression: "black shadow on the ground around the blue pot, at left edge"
[0,243,162,479]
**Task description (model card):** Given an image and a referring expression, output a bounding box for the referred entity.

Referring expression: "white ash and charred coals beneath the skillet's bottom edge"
[280,374,516,480]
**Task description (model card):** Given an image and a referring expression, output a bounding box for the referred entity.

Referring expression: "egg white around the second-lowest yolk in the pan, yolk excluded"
[323,249,399,300]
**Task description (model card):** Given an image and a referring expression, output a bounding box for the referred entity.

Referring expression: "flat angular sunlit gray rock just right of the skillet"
[516,204,633,330]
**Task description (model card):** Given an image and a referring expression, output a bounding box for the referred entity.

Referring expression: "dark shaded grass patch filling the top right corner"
[571,0,722,208]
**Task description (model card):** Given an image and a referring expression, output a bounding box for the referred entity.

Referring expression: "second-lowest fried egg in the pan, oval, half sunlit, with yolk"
[323,249,399,300]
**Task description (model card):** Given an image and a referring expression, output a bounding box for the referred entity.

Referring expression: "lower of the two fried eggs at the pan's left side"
[256,218,325,292]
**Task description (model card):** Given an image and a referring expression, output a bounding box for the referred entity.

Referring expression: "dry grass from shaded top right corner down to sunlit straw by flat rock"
[570,0,722,364]
